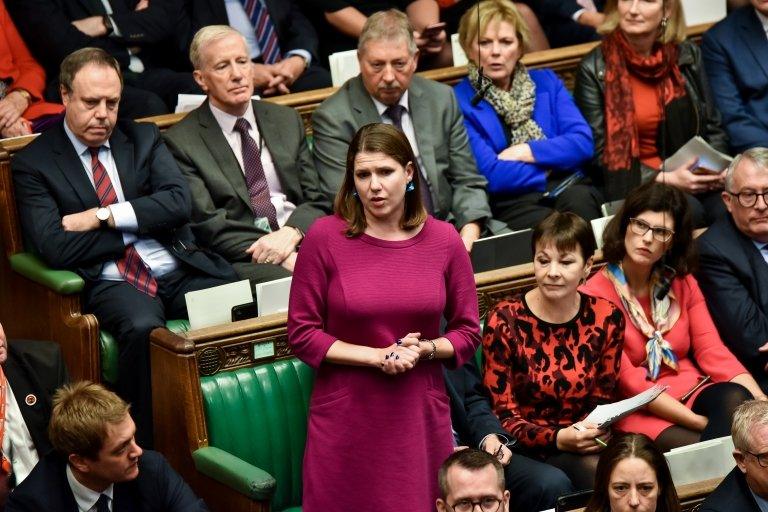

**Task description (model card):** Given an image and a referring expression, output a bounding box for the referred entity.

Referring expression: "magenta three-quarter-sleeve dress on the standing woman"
[288,217,480,512]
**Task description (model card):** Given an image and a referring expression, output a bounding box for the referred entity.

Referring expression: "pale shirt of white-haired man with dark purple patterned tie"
[208,102,296,227]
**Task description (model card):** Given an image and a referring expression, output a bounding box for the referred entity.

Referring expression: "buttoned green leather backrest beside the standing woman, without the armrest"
[200,358,314,510]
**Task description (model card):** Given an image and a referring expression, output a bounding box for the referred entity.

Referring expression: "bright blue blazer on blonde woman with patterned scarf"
[454,69,595,194]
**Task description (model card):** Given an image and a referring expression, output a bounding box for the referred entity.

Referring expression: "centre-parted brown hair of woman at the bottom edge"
[584,434,680,512]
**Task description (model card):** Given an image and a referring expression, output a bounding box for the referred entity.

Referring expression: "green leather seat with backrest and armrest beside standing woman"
[198,357,314,512]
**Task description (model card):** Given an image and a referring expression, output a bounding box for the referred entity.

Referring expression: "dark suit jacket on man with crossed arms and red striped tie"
[11,121,236,280]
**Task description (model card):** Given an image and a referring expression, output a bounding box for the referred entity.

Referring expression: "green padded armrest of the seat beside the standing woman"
[192,446,275,501]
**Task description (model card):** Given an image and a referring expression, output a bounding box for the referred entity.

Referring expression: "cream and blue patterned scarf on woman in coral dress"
[602,263,680,382]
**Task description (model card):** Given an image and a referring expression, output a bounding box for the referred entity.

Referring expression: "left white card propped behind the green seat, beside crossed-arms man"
[184,279,253,329]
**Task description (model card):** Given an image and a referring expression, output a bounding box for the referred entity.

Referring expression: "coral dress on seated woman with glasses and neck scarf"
[581,272,747,439]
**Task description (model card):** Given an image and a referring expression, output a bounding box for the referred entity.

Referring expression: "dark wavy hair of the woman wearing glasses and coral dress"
[603,181,698,275]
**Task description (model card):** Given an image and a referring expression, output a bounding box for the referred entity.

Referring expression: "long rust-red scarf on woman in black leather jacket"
[601,30,685,171]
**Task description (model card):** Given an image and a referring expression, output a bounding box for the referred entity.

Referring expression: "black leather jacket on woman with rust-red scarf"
[574,41,728,201]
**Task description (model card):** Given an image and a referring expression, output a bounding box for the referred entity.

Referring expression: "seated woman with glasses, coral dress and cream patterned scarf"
[583,182,764,451]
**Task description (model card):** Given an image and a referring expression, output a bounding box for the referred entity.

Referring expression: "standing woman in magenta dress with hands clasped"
[288,124,480,512]
